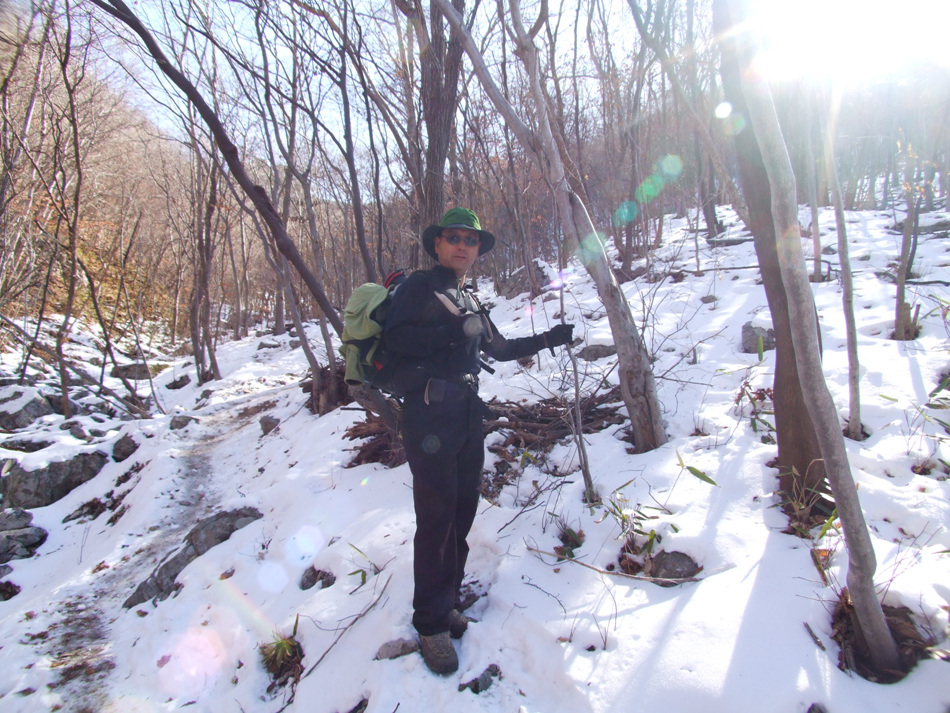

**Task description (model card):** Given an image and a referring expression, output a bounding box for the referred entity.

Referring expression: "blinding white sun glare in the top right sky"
[751,0,950,85]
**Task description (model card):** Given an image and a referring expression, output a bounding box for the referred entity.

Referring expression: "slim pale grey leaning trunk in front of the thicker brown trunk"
[714,0,900,674]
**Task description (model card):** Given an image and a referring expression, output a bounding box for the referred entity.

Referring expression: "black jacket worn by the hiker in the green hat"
[384,265,544,392]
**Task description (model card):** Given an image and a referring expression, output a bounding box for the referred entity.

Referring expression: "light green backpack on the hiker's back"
[340,270,406,393]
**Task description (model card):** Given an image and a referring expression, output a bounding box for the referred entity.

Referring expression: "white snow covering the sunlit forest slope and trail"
[0,203,950,713]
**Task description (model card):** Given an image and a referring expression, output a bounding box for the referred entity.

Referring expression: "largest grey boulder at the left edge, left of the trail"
[0,451,106,508]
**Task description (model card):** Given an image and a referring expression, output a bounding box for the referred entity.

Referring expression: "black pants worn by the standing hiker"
[402,382,485,636]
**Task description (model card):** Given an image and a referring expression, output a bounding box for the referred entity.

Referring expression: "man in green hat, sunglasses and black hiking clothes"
[385,208,574,674]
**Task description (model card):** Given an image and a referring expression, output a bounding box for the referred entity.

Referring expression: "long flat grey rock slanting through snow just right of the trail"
[122,507,263,609]
